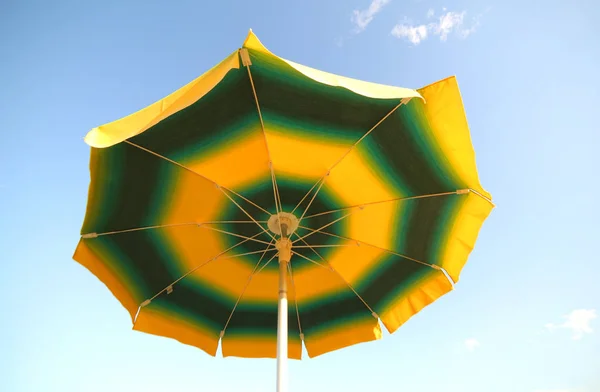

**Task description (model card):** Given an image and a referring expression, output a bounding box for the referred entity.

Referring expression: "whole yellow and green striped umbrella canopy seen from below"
[74,28,493,388]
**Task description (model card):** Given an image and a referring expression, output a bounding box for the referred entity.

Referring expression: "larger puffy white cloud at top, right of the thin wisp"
[391,8,481,45]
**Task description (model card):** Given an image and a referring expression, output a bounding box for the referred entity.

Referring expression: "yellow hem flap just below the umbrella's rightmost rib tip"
[441,193,494,283]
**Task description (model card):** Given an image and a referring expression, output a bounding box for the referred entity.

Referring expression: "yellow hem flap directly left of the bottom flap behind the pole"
[133,304,219,357]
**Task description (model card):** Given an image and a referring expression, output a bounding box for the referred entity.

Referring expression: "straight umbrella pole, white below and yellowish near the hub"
[277,237,292,392]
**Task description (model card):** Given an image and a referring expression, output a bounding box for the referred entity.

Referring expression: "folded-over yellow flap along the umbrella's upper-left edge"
[85,50,239,148]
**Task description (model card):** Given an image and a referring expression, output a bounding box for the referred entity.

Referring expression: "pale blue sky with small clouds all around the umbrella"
[0,0,600,392]
